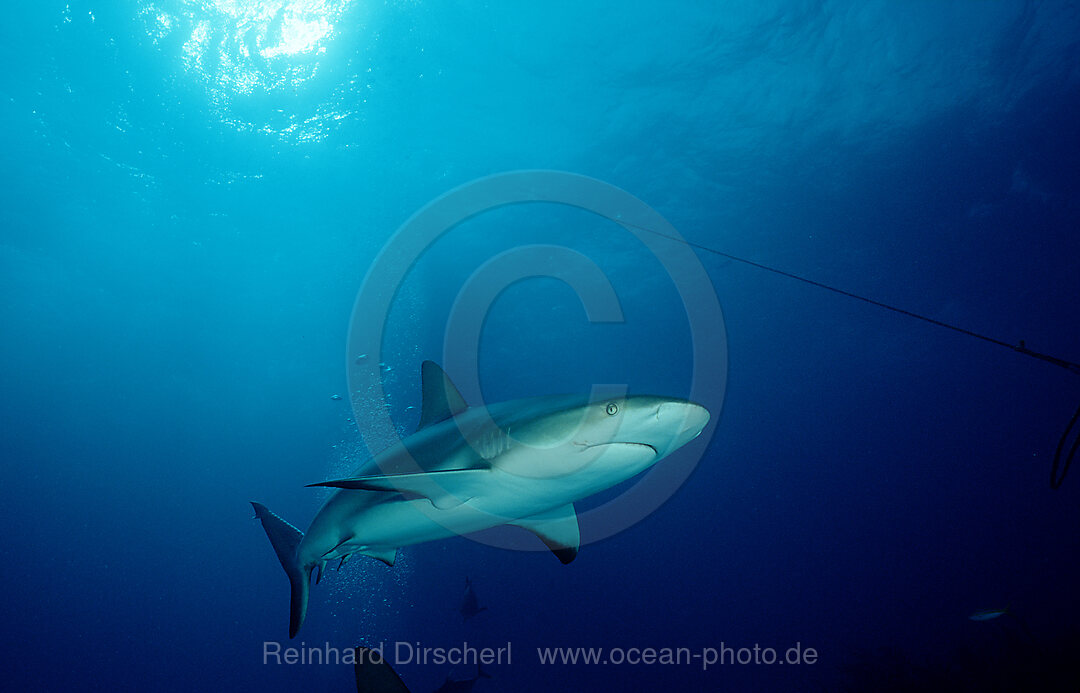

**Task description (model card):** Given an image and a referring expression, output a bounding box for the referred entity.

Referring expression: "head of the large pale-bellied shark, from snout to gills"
[494,395,708,488]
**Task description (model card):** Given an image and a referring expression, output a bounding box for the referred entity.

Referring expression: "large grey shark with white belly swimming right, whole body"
[252,361,710,638]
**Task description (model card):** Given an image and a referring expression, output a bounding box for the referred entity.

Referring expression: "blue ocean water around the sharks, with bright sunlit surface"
[0,0,1080,693]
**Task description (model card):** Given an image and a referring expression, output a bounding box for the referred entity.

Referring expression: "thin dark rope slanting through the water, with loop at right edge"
[612,219,1080,490]
